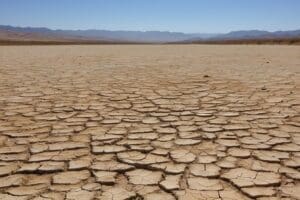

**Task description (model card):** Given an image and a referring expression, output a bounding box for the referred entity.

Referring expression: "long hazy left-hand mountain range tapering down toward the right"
[0,25,217,42]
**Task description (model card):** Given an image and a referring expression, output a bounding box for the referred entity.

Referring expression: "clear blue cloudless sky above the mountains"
[0,0,300,33]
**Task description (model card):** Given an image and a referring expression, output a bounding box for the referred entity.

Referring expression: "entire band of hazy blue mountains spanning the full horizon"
[0,25,300,43]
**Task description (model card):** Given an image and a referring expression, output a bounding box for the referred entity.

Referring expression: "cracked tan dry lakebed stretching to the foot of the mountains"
[0,45,300,200]
